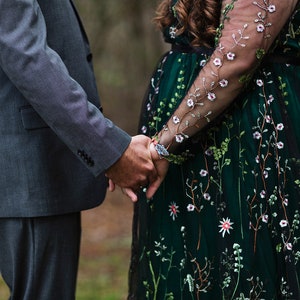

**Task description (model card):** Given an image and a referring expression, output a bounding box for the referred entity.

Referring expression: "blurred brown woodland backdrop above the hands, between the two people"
[75,0,165,134]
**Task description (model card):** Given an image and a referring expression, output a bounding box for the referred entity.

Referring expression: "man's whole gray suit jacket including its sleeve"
[0,0,130,217]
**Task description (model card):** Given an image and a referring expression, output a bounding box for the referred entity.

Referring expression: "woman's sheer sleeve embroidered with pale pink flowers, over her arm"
[157,0,298,152]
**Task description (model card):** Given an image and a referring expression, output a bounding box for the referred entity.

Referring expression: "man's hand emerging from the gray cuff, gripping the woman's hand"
[106,135,157,192]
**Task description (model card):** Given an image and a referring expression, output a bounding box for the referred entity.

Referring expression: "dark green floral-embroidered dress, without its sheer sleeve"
[129,0,300,300]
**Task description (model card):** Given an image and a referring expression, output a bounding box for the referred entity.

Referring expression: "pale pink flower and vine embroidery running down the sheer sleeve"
[152,0,282,148]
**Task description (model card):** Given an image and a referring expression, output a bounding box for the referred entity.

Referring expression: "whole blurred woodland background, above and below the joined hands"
[0,0,167,300]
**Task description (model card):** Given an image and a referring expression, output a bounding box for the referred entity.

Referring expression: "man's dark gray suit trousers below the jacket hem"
[0,213,81,300]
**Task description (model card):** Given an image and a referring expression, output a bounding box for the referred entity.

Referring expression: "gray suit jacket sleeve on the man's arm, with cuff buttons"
[0,0,131,176]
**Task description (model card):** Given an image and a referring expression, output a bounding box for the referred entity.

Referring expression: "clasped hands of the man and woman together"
[106,135,169,202]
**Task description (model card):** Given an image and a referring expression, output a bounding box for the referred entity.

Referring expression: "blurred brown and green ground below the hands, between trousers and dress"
[77,190,133,300]
